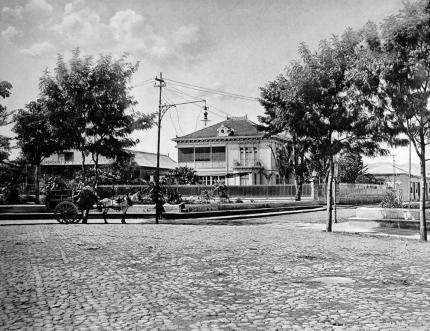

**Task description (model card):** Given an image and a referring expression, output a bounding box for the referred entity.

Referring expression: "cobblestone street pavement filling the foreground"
[0,212,430,330]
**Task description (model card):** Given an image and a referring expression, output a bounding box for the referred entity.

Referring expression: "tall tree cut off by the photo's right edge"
[355,1,430,241]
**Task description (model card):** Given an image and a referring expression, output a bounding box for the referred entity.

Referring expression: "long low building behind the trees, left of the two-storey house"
[41,150,176,180]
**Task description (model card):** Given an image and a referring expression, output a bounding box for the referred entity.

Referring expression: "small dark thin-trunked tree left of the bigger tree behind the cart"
[13,100,60,202]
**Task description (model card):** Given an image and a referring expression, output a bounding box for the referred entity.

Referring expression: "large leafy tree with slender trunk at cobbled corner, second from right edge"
[262,30,384,232]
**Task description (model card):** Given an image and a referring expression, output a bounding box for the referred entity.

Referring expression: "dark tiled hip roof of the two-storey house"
[173,118,263,141]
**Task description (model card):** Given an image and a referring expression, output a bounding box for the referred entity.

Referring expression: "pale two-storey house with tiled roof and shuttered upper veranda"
[173,117,283,186]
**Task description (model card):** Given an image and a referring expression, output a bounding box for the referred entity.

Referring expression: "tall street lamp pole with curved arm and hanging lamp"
[155,72,208,224]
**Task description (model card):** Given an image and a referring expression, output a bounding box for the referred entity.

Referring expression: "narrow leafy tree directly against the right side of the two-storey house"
[258,71,311,201]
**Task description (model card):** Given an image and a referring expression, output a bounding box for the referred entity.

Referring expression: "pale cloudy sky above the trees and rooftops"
[0,0,417,163]
